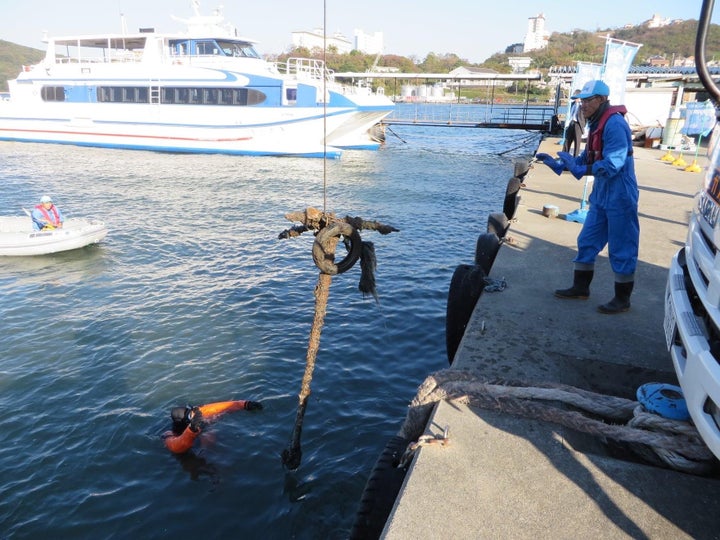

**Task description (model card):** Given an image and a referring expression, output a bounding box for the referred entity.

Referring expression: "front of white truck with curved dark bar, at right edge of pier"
[665,0,720,458]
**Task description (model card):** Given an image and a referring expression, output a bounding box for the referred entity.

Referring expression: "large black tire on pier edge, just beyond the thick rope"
[445,264,486,365]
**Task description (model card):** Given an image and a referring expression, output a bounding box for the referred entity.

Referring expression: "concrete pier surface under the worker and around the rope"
[383,139,720,540]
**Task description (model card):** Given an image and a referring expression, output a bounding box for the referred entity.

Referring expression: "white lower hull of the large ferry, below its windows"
[0,102,372,157]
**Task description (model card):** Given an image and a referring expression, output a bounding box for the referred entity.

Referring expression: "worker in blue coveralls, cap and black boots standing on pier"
[535,81,640,314]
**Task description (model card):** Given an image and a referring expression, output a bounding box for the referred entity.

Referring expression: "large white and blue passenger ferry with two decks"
[0,2,394,158]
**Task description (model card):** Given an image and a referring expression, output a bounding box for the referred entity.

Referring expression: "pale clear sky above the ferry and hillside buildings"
[0,0,720,63]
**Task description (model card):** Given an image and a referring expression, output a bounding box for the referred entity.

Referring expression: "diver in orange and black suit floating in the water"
[163,399,262,454]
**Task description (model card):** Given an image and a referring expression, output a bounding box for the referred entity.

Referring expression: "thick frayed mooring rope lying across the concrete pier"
[400,369,717,474]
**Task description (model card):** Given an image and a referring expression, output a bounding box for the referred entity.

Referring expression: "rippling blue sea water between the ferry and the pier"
[0,126,539,539]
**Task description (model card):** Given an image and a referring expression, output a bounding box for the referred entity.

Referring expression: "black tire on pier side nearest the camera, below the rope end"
[350,435,410,540]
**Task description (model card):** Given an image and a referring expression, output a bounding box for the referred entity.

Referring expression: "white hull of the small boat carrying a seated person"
[0,216,108,257]
